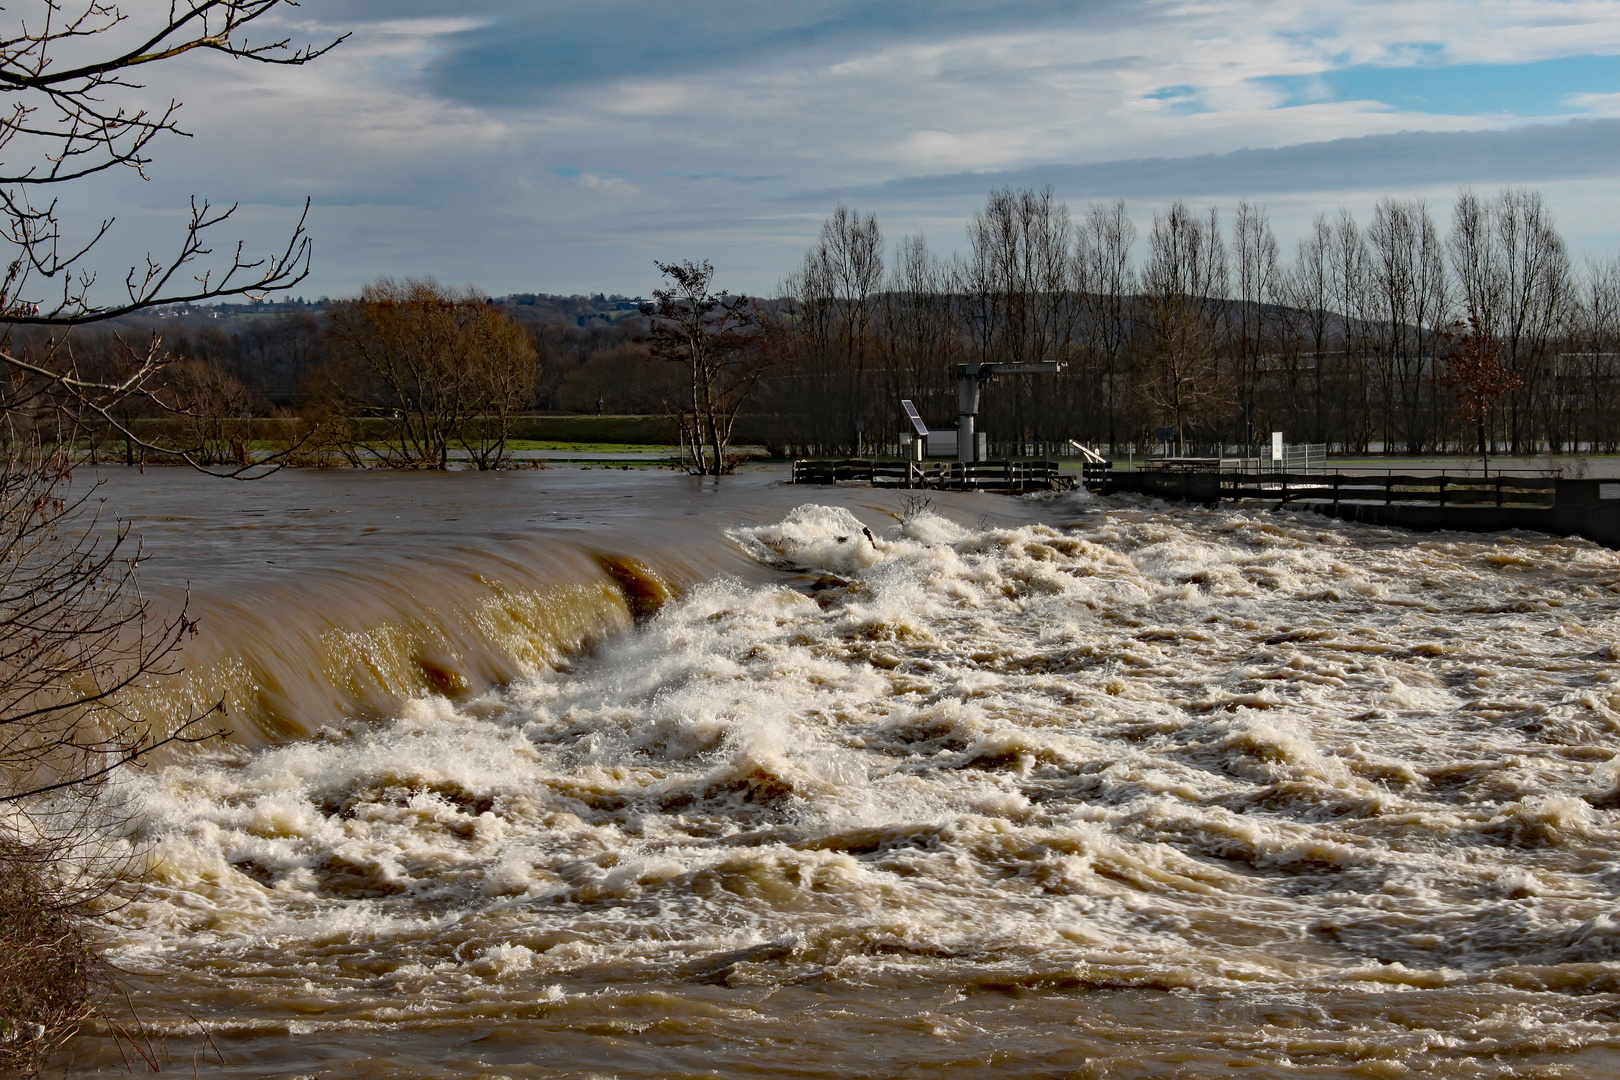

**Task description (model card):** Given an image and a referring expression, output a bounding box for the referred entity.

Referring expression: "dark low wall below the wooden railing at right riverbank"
[1103,471,1620,551]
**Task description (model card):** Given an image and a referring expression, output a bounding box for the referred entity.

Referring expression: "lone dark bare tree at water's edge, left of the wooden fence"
[642,259,770,476]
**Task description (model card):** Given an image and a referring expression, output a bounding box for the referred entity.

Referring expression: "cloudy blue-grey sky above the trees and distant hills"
[53,0,1620,296]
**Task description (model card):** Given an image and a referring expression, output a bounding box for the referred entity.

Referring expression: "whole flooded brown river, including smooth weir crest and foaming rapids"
[44,470,1620,1080]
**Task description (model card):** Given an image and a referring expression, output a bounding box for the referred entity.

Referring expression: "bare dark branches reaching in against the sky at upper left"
[0,0,337,474]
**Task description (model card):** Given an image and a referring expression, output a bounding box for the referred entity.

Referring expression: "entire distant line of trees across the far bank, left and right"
[16,188,1620,453]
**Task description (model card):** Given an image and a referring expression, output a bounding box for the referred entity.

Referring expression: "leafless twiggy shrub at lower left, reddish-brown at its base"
[0,442,224,1069]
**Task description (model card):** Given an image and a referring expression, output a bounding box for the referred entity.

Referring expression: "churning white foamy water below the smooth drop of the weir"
[85,500,1620,1077]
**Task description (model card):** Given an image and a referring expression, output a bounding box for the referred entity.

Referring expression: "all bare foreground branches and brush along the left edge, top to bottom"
[0,0,335,1070]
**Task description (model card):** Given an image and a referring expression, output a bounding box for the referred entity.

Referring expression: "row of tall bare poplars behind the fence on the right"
[753,188,1620,453]
